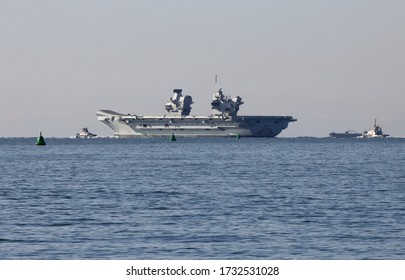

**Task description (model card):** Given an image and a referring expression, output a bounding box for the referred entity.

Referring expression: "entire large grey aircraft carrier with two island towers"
[97,89,296,137]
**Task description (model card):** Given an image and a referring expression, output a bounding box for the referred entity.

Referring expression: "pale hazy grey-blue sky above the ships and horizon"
[0,0,405,137]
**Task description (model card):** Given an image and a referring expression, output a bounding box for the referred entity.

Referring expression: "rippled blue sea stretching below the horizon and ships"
[0,138,405,259]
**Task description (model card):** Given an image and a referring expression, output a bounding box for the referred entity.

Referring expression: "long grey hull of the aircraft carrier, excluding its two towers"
[97,110,296,138]
